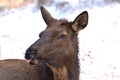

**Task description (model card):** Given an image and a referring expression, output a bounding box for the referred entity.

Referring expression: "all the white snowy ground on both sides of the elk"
[0,4,120,80]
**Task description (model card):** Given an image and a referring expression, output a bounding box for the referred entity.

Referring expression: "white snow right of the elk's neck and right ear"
[79,4,120,80]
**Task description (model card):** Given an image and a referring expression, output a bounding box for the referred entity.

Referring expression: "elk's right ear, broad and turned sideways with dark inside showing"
[72,11,88,33]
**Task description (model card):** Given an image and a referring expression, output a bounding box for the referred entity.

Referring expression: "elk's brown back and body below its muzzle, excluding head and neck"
[0,59,53,80]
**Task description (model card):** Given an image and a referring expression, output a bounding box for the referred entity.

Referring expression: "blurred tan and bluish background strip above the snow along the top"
[0,0,120,12]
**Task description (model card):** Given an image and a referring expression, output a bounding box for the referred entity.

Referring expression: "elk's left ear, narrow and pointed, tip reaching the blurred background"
[40,6,54,25]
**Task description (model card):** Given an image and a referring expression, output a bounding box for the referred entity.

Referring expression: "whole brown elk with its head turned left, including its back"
[0,6,88,80]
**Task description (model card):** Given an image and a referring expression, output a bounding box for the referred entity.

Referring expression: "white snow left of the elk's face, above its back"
[0,8,45,59]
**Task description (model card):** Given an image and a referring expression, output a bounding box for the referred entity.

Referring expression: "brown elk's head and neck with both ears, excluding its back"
[25,7,88,80]
